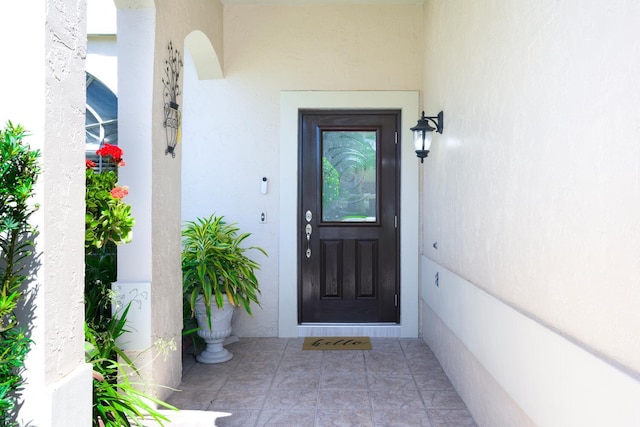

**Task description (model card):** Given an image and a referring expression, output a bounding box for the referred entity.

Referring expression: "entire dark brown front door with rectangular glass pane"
[298,110,400,323]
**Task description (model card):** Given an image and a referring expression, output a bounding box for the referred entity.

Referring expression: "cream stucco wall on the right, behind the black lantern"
[422,0,640,425]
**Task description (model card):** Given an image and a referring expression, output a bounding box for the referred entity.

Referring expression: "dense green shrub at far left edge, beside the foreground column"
[0,122,40,426]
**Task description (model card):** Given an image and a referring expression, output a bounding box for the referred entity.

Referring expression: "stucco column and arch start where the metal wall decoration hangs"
[116,0,222,398]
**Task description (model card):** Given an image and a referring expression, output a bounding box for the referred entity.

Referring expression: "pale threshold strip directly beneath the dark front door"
[298,323,402,338]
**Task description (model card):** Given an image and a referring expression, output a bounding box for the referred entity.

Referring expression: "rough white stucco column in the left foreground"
[0,0,91,426]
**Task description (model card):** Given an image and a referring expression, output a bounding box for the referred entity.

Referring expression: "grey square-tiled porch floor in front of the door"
[168,338,476,427]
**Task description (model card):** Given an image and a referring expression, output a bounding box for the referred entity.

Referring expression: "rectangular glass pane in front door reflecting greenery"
[322,131,377,222]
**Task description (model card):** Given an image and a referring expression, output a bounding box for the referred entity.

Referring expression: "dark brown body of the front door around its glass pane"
[298,109,402,324]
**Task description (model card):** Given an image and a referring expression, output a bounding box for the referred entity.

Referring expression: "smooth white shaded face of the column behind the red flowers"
[116,8,155,351]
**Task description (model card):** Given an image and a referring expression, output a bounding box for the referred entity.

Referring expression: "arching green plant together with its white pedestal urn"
[182,214,267,363]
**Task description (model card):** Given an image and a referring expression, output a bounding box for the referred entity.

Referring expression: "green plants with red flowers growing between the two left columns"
[84,144,176,427]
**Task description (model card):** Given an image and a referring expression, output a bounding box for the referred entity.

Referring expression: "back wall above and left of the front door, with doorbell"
[182,4,422,336]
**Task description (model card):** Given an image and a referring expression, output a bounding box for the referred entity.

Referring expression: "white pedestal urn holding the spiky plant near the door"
[195,295,234,363]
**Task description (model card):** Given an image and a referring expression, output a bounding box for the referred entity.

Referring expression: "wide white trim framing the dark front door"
[278,91,420,337]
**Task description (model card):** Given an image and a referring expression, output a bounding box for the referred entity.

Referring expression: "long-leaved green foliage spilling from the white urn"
[182,214,267,327]
